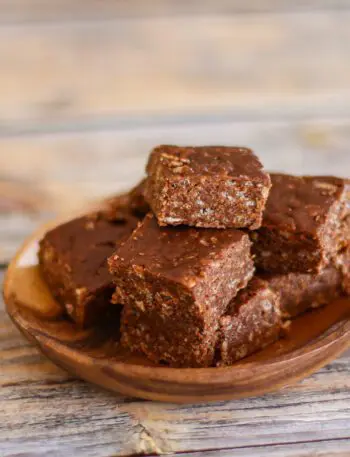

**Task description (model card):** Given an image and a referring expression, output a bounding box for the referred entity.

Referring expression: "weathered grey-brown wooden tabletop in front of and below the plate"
[0,274,350,457]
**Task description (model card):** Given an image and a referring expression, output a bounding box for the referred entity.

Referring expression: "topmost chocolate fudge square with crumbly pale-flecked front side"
[145,146,271,229]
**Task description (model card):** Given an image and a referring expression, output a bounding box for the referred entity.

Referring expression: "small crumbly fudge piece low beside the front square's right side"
[217,278,283,365]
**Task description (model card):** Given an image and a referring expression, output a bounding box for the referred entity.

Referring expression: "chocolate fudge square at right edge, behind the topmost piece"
[252,174,350,273]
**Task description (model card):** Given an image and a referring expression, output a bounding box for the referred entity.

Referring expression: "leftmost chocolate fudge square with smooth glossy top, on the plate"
[39,215,137,327]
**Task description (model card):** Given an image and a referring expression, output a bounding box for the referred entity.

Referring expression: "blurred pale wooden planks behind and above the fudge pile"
[0,0,350,263]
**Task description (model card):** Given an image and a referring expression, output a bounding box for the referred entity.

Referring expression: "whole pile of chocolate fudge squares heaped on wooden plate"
[39,146,350,367]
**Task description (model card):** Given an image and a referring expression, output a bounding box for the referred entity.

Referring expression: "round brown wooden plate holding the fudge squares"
[4,221,350,403]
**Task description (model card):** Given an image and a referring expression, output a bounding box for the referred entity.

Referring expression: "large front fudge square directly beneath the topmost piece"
[109,214,254,367]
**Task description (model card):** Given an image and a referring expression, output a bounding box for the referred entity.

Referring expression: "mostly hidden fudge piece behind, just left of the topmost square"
[96,179,150,221]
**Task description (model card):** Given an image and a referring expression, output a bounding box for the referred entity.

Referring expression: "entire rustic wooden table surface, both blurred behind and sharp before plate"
[0,0,350,457]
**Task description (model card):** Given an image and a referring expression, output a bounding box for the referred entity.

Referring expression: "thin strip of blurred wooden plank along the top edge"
[0,0,349,22]
